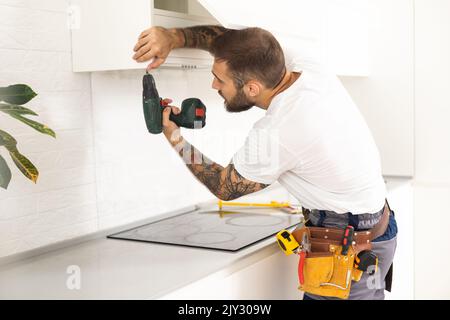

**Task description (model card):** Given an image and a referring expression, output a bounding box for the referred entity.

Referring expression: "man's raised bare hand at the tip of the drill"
[133,27,184,70]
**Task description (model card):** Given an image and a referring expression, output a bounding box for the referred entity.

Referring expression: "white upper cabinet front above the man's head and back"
[199,0,369,76]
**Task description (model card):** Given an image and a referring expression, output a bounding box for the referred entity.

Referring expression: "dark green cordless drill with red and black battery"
[142,73,206,134]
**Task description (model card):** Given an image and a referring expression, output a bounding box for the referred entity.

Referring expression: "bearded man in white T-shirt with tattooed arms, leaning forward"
[133,26,397,299]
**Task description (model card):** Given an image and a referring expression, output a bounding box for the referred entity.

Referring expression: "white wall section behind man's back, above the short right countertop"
[341,0,414,176]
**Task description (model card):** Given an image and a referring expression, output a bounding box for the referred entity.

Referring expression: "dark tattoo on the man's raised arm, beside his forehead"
[181,26,229,51]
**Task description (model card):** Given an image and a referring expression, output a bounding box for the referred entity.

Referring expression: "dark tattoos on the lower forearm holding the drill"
[178,140,269,201]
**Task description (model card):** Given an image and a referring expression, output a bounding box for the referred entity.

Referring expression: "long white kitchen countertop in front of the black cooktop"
[0,205,298,299]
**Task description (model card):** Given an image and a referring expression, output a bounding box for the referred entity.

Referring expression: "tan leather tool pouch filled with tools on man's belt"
[277,226,378,299]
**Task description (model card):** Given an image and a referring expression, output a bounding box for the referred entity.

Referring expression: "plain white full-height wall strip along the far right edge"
[414,0,450,299]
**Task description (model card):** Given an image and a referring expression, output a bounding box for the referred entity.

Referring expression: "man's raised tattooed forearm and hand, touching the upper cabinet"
[133,26,228,70]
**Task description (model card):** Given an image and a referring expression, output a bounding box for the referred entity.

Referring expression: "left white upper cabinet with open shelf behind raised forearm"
[69,0,217,72]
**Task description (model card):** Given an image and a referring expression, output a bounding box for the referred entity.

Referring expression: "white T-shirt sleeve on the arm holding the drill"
[232,128,296,184]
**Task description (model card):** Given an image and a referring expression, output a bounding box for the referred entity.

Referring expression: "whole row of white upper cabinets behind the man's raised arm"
[69,0,369,76]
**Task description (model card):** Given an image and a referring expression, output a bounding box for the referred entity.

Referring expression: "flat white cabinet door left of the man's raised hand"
[70,0,152,72]
